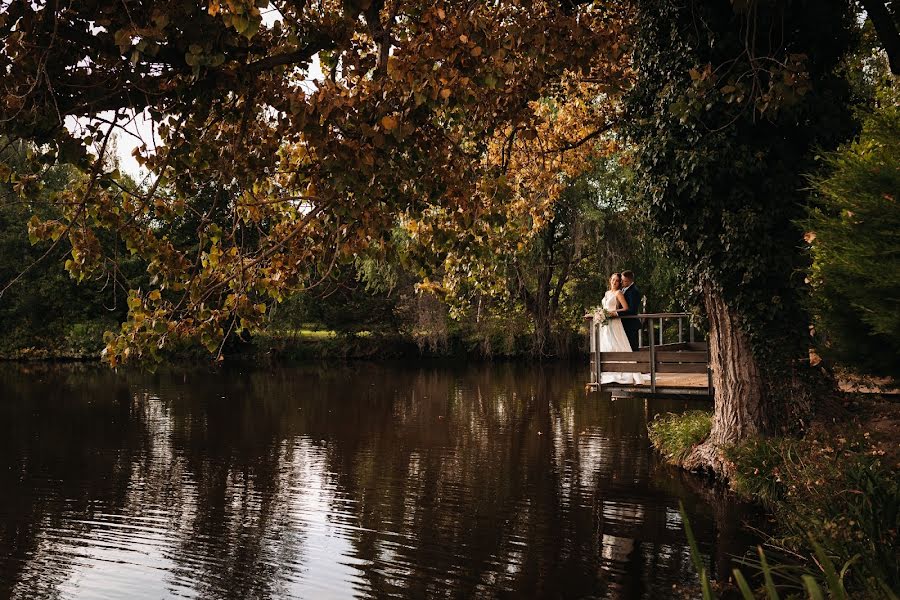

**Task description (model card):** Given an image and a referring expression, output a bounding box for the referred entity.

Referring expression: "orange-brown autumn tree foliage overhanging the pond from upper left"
[0,0,624,363]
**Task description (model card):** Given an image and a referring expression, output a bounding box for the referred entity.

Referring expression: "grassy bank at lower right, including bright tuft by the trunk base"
[650,395,900,598]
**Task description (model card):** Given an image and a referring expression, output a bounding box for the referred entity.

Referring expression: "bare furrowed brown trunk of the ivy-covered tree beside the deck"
[684,282,773,478]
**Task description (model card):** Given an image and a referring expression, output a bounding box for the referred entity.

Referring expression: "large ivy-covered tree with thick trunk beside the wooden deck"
[629,0,854,471]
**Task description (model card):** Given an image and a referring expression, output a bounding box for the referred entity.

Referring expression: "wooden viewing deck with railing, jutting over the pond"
[585,313,713,398]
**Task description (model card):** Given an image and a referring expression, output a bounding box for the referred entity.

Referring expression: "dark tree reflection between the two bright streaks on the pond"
[135,374,312,598]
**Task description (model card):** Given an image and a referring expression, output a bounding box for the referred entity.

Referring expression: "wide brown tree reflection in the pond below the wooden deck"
[310,367,752,597]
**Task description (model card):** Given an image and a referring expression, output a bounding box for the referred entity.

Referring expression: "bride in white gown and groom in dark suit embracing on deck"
[600,271,649,384]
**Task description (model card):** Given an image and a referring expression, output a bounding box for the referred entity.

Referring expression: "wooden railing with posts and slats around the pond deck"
[585,313,713,396]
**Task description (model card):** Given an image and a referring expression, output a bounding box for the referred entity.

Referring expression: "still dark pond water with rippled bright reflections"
[0,363,750,599]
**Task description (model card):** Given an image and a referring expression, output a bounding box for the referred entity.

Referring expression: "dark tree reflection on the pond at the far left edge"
[0,365,147,598]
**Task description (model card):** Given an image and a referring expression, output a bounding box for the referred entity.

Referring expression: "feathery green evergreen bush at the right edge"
[807,105,900,377]
